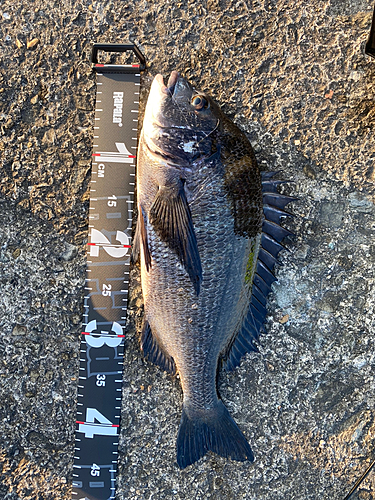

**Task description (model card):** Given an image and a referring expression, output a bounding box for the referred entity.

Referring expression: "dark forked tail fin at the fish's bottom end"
[177,400,254,469]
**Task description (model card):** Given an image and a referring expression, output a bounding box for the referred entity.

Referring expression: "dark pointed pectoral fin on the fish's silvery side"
[150,181,202,295]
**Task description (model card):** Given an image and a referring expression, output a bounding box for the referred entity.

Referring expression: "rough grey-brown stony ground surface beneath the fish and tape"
[0,0,375,500]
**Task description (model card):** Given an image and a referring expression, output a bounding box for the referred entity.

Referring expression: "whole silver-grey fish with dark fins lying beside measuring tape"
[132,71,293,469]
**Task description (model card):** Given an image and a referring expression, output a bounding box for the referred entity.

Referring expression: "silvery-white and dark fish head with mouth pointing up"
[143,71,221,165]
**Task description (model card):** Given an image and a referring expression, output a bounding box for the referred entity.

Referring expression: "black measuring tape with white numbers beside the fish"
[72,44,145,500]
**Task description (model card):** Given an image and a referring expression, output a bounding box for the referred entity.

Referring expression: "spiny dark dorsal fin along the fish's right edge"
[223,172,296,371]
